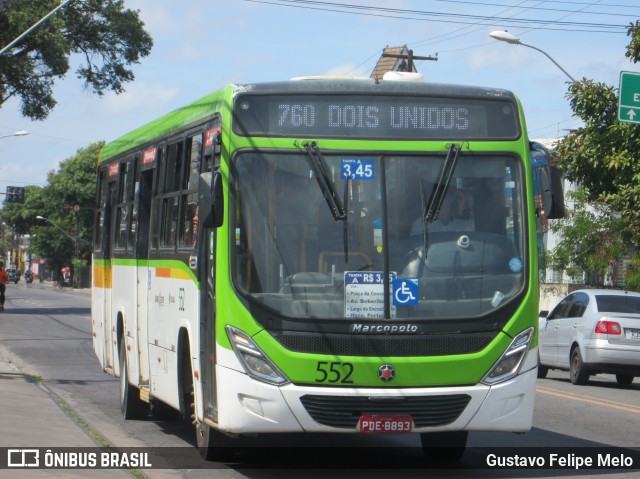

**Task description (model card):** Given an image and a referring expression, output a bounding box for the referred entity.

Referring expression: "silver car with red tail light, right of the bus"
[538,289,640,386]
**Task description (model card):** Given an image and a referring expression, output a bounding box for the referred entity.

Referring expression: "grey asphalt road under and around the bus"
[0,283,640,479]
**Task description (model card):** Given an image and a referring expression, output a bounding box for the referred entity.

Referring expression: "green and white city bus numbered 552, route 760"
[92,78,559,464]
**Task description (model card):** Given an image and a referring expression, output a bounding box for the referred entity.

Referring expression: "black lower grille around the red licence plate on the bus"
[300,394,471,429]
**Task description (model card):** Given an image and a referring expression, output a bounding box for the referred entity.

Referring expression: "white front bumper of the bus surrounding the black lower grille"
[216,350,537,434]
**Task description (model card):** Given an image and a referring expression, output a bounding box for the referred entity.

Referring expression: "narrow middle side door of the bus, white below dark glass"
[134,169,154,386]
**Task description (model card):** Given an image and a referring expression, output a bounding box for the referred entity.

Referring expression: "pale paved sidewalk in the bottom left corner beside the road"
[0,357,133,479]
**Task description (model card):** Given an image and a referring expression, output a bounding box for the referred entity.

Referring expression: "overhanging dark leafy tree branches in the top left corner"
[0,0,153,120]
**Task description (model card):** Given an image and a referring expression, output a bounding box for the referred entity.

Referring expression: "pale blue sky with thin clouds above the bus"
[0,0,640,197]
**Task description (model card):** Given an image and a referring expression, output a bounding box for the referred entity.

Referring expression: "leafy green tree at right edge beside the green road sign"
[553,21,640,288]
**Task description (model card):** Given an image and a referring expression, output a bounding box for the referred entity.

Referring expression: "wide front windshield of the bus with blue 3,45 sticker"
[230,149,527,320]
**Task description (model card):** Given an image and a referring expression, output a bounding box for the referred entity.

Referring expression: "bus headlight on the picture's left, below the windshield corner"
[226,325,289,386]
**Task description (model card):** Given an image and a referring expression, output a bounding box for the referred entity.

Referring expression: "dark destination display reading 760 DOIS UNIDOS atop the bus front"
[235,95,519,140]
